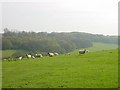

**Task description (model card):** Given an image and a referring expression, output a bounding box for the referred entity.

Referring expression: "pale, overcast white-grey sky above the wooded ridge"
[0,0,119,35]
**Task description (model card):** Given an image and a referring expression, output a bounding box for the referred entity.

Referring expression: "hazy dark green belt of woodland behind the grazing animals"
[2,28,117,53]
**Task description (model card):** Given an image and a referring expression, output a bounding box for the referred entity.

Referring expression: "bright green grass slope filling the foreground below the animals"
[2,42,118,88]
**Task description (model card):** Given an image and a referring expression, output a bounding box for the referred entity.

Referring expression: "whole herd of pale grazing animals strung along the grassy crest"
[3,49,89,60]
